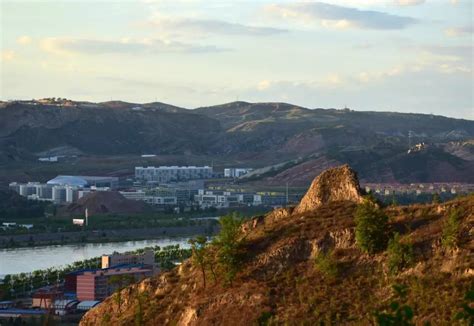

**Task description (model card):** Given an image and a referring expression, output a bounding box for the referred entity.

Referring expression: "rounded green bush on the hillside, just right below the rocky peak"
[355,199,388,254]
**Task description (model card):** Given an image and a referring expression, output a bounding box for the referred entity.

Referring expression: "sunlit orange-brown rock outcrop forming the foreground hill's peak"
[293,164,363,214]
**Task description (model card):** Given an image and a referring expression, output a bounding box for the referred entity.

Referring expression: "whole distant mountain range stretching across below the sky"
[0,99,474,185]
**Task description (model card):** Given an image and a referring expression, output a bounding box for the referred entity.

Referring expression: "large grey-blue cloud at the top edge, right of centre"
[265,2,417,30]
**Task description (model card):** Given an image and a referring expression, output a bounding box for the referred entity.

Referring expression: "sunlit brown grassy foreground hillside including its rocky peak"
[81,166,474,326]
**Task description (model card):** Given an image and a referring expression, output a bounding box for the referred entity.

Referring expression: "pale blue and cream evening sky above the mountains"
[0,0,474,119]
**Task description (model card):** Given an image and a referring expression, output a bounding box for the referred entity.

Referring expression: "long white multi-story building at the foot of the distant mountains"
[135,166,213,183]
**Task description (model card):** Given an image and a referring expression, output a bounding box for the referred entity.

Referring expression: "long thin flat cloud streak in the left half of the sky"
[40,37,226,54]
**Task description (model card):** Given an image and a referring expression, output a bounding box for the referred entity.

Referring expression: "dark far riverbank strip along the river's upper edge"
[0,221,218,249]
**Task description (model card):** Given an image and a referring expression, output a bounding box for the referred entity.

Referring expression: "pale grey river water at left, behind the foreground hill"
[0,238,189,278]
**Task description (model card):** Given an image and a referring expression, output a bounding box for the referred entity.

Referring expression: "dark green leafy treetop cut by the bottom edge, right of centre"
[374,284,414,326]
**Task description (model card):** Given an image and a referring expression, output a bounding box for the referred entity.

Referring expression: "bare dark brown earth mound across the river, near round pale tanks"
[61,191,149,215]
